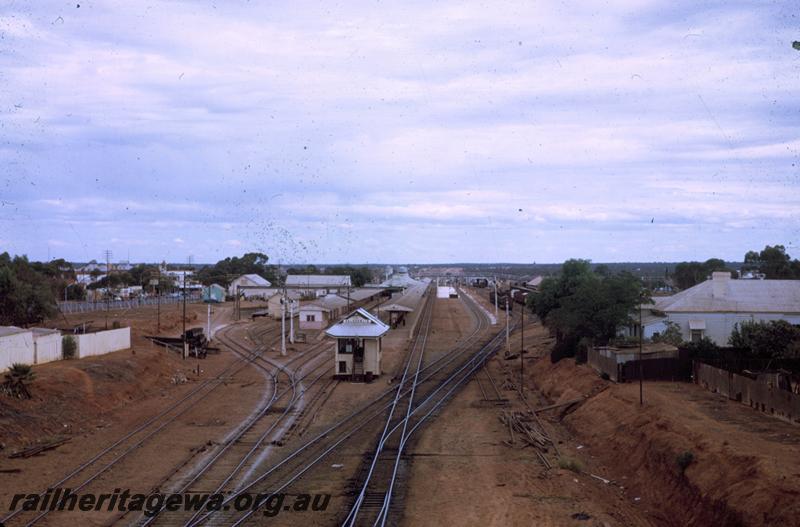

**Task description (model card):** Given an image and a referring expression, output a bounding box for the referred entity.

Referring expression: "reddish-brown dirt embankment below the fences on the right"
[529,358,800,525]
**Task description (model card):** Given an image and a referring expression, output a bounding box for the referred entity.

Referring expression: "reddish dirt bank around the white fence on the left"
[0,306,205,452]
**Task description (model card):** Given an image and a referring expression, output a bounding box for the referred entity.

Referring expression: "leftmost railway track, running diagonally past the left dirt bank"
[0,320,278,526]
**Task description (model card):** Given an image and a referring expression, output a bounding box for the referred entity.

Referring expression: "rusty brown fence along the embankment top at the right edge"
[692,361,800,422]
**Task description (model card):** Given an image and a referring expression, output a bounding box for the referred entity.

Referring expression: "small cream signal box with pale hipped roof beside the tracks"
[325,308,389,382]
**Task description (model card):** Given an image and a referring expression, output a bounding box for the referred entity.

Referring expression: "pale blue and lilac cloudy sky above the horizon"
[0,0,800,263]
